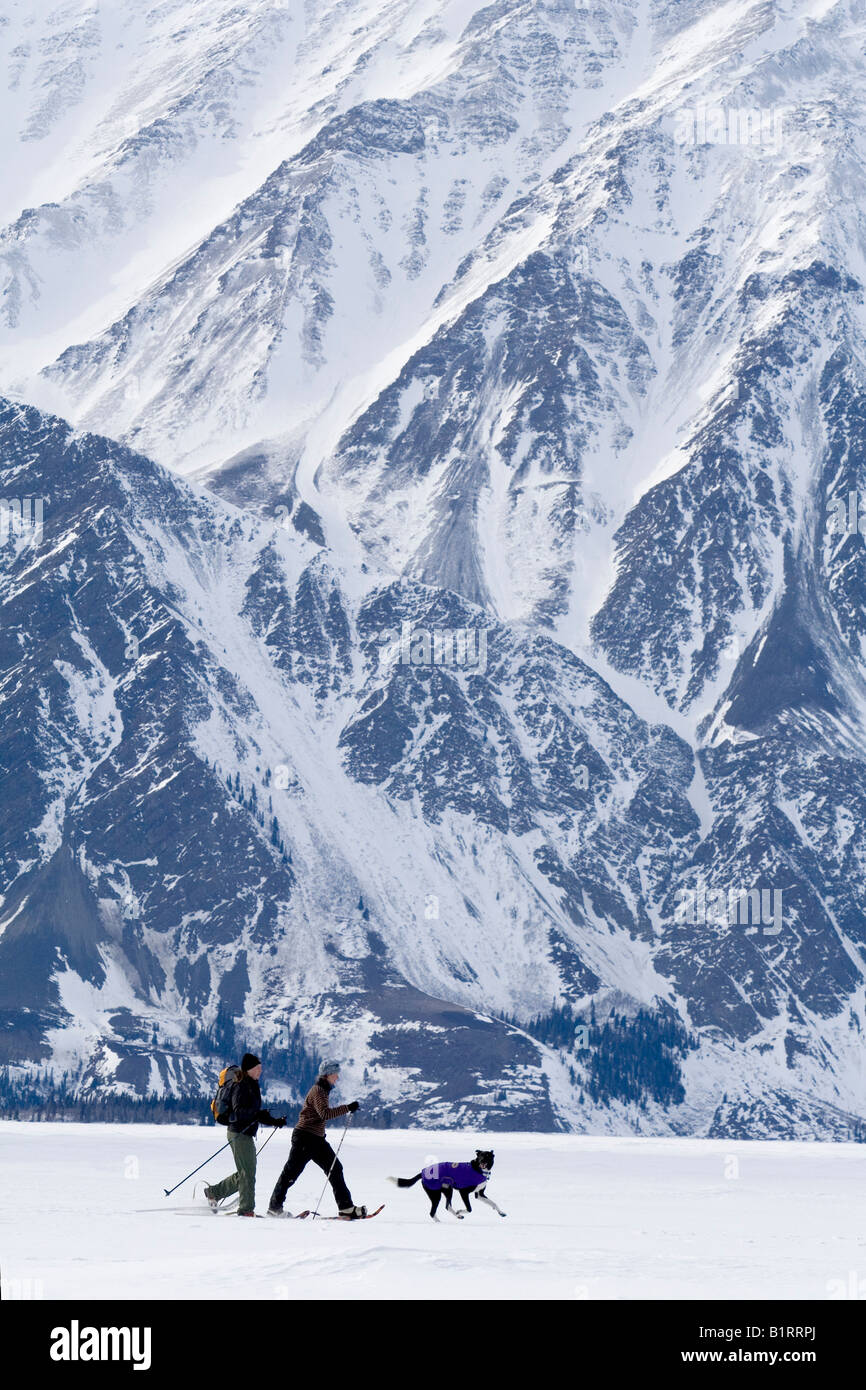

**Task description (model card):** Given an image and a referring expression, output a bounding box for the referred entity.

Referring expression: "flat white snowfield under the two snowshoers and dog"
[0,1120,866,1300]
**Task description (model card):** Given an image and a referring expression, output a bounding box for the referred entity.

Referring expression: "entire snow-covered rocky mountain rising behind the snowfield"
[0,0,866,1134]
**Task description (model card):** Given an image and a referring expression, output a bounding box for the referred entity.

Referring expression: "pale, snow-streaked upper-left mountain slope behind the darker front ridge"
[4,3,634,467]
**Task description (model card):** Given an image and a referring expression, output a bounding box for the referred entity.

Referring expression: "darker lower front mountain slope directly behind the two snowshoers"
[0,394,863,1130]
